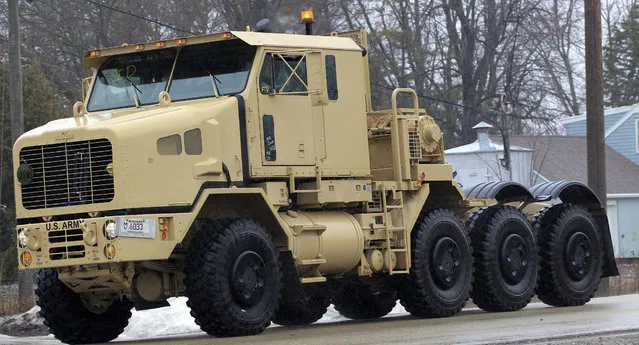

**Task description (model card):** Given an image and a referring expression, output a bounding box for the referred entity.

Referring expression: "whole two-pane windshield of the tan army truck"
[87,40,256,111]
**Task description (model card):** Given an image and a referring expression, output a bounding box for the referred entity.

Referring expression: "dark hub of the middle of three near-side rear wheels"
[500,234,528,284]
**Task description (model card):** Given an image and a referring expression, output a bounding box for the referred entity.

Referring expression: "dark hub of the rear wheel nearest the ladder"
[431,237,461,288]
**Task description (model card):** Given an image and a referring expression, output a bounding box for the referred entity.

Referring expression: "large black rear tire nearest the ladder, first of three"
[399,209,472,317]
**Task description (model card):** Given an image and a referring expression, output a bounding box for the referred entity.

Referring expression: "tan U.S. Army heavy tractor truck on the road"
[13,11,617,343]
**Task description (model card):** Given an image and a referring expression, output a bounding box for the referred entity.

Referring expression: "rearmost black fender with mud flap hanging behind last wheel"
[532,181,619,278]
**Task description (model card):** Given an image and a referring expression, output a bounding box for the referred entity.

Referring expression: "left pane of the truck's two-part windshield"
[87,49,176,111]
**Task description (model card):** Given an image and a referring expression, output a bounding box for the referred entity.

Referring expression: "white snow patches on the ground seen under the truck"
[0,297,408,344]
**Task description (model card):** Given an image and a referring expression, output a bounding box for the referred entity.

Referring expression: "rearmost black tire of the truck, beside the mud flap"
[533,204,603,306]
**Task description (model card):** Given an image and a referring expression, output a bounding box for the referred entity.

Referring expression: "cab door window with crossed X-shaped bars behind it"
[260,53,308,95]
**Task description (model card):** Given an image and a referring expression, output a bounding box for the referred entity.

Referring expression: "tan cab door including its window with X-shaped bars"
[257,52,315,165]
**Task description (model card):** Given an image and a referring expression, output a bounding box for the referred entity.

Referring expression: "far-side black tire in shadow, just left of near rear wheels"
[332,278,397,320]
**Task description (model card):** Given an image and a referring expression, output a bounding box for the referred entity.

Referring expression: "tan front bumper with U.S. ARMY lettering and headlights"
[16,214,182,269]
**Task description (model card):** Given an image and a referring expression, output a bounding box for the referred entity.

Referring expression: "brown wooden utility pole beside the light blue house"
[585,0,607,207]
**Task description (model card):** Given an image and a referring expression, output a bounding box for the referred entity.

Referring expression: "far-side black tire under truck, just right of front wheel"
[273,284,331,326]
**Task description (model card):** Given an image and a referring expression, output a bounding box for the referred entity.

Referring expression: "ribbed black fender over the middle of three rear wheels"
[464,181,534,204]
